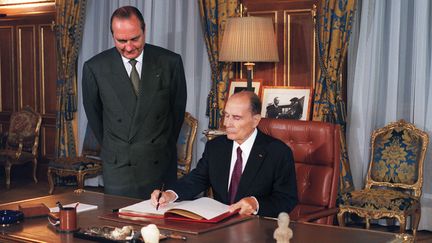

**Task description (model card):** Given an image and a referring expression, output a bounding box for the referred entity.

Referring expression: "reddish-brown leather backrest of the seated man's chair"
[258,118,340,224]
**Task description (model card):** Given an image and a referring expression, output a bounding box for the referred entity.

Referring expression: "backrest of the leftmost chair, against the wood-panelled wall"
[6,106,42,155]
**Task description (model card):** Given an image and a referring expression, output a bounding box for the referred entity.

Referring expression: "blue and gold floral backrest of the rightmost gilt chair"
[365,120,429,197]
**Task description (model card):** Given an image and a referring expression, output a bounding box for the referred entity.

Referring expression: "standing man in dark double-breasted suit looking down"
[82,6,186,199]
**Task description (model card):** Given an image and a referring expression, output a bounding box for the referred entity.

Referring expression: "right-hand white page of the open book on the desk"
[172,197,229,220]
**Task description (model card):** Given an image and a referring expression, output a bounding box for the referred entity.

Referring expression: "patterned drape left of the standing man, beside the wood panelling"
[55,0,86,157]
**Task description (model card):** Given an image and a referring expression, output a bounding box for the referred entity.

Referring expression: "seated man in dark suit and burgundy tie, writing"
[151,91,297,217]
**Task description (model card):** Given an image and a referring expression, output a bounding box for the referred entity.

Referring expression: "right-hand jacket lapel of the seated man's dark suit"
[236,131,266,201]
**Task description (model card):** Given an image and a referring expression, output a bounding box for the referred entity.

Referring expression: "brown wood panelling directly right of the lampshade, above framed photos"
[242,0,317,88]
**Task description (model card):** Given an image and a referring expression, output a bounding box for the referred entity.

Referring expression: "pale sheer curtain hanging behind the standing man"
[78,0,211,176]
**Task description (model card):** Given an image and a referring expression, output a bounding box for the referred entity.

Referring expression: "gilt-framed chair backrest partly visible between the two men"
[177,112,198,178]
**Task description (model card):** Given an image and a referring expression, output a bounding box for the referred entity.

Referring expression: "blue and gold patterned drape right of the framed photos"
[313,0,355,193]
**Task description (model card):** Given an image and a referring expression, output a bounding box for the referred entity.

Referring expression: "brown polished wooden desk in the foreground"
[0,192,396,243]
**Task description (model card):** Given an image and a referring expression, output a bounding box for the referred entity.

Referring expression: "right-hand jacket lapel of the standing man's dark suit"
[129,48,161,139]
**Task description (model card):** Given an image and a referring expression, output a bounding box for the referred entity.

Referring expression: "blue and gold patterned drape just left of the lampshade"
[198,0,237,129]
